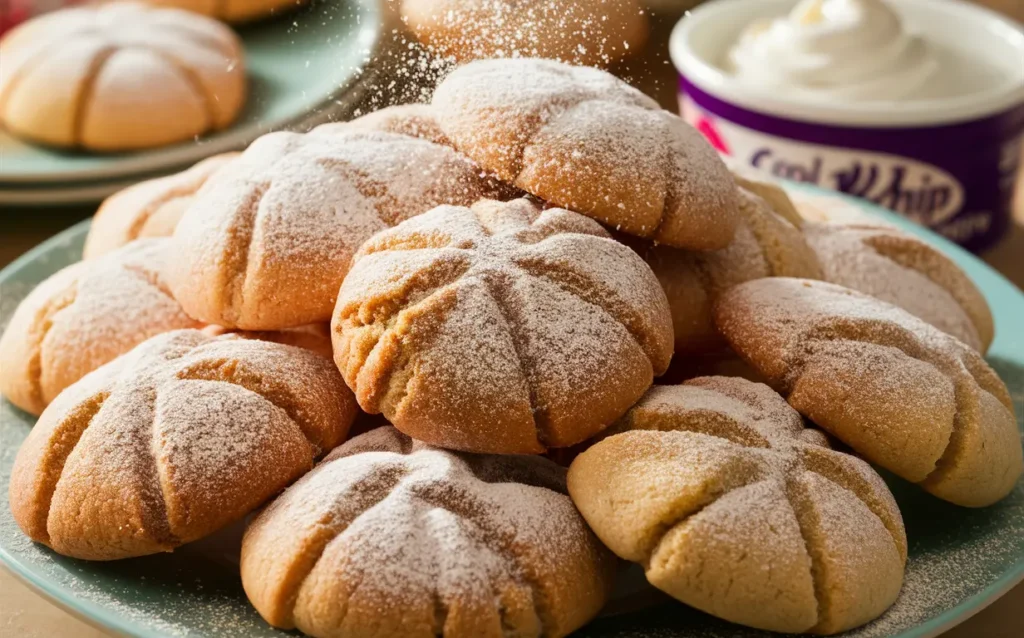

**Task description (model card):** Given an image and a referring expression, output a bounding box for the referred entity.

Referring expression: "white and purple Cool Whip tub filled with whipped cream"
[671,0,1024,251]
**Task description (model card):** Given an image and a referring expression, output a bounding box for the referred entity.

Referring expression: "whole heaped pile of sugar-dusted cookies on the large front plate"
[0,59,1022,637]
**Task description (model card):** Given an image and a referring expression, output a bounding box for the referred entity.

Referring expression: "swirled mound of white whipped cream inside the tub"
[728,0,942,101]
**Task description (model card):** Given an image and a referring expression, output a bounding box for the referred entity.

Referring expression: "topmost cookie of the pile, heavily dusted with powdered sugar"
[432,59,739,250]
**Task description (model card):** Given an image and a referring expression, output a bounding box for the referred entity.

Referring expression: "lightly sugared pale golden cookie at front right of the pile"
[568,377,906,634]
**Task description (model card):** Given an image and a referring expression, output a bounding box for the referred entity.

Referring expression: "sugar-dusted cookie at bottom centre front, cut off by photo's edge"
[242,427,615,638]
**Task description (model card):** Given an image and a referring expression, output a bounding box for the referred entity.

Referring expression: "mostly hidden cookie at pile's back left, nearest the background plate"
[82,153,239,259]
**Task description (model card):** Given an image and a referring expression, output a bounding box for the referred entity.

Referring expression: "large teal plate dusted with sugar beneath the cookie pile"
[0,190,1024,638]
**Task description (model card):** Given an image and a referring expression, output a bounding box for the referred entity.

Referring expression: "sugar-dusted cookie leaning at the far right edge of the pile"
[715,278,1024,507]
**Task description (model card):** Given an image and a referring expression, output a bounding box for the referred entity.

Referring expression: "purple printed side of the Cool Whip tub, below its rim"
[680,79,1024,251]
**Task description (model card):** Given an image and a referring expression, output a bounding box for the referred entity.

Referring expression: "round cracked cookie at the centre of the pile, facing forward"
[332,200,672,454]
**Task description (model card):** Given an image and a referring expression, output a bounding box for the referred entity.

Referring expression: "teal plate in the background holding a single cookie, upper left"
[0,0,383,187]
